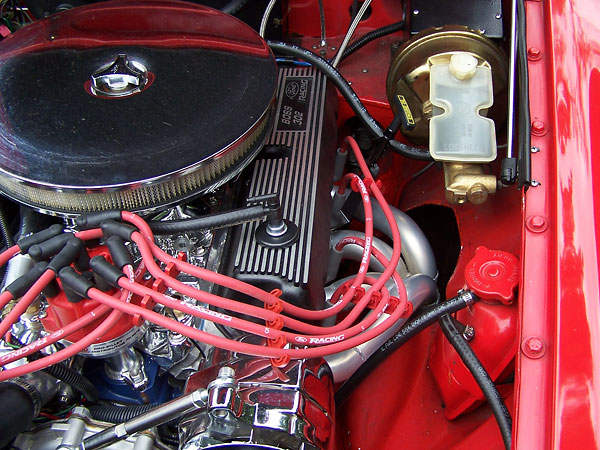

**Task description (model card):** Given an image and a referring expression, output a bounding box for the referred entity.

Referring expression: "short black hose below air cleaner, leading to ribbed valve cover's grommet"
[148,205,270,234]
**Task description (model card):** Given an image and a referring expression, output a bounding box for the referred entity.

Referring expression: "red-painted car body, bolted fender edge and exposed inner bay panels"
[288,0,600,449]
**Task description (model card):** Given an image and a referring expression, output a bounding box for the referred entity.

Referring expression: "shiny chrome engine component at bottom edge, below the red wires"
[180,350,334,450]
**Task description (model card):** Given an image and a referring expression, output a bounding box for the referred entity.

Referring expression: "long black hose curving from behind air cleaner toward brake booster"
[267,41,433,161]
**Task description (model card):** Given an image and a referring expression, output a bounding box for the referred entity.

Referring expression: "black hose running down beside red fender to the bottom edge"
[439,315,512,449]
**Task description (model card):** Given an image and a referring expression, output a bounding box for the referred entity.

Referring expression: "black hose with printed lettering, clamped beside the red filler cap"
[335,292,478,406]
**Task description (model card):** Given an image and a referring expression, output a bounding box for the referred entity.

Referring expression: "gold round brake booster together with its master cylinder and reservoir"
[387,25,508,204]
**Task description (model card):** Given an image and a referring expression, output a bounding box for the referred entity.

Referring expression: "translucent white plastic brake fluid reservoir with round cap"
[429,52,496,163]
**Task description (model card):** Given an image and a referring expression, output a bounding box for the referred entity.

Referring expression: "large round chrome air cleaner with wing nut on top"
[0,1,277,215]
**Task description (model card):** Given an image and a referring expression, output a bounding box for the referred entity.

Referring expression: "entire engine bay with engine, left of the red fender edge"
[0,0,528,450]
